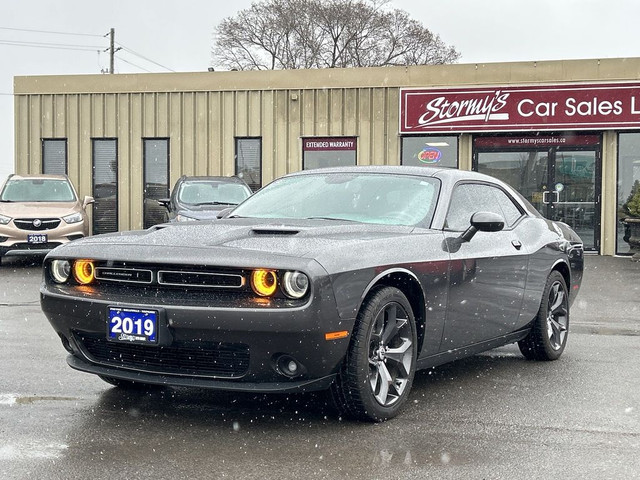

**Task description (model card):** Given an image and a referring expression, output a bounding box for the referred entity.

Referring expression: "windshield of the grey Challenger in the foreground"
[231,172,439,226]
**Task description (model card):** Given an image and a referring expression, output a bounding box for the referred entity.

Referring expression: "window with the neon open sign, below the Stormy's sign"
[401,135,458,168]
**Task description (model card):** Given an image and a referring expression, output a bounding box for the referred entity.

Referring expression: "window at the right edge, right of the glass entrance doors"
[616,132,640,254]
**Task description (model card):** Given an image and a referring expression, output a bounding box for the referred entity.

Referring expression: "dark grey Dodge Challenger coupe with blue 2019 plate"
[41,167,583,421]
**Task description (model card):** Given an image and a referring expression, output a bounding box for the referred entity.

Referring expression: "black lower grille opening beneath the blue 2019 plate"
[75,333,249,378]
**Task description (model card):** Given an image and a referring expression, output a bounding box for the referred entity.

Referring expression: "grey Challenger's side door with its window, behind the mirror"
[441,183,528,351]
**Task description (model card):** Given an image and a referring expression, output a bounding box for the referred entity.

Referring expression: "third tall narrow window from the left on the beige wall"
[143,138,169,228]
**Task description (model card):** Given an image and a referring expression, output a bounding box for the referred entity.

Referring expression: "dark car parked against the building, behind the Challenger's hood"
[158,175,251,222]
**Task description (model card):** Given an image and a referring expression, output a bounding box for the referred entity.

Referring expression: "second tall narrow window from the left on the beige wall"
[92,138,118,235]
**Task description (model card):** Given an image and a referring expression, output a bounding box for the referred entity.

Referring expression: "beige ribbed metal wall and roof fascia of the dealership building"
[14,58,640,254]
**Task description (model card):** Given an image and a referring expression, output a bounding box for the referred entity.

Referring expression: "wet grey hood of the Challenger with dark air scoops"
[50,218,440,267]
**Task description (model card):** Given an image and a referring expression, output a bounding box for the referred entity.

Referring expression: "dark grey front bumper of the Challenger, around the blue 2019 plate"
[41,277,355,392]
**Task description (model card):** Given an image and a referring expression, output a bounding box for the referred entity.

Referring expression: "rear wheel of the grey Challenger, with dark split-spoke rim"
[518,270,569,360]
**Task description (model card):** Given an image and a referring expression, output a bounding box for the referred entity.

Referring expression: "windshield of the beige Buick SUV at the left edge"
[0,178,76,202]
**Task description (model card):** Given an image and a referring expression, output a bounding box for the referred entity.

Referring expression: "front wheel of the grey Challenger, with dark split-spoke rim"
[332,287,418,422]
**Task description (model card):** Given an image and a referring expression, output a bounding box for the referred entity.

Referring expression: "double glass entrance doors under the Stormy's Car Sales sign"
[474,135,600,252]
